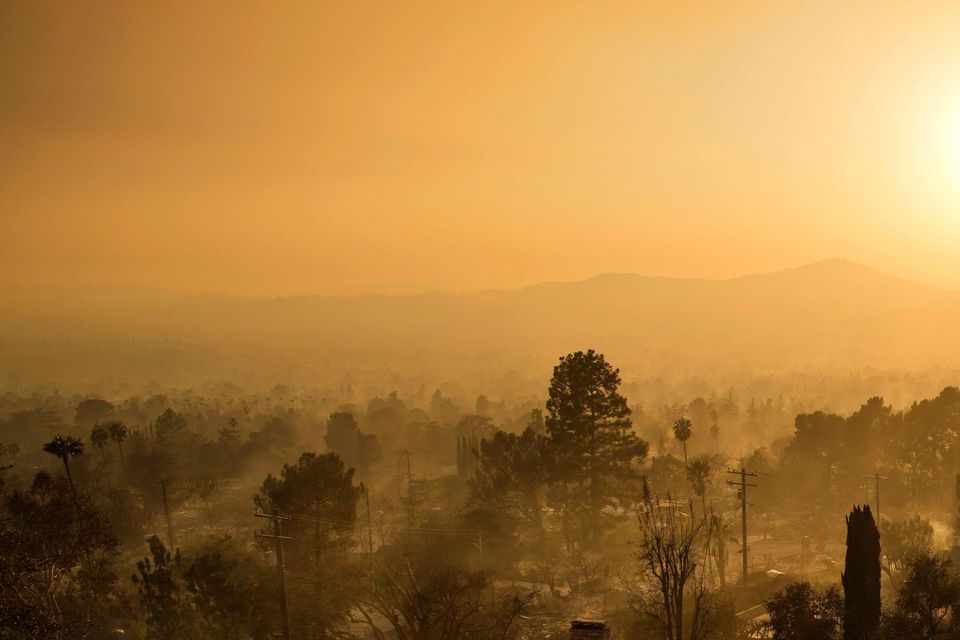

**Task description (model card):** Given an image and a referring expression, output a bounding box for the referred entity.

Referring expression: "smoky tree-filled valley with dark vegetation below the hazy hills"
[0,351,960,640]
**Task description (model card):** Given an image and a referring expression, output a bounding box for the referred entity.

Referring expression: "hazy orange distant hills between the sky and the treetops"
[0,260,960,388]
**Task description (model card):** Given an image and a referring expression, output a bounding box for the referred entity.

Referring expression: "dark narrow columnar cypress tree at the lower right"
[840,505,880,640]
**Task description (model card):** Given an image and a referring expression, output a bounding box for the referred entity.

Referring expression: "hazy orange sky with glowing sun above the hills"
[0,0,960,294]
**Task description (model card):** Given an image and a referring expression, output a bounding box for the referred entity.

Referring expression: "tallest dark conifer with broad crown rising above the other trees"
[546,349,648,544]
